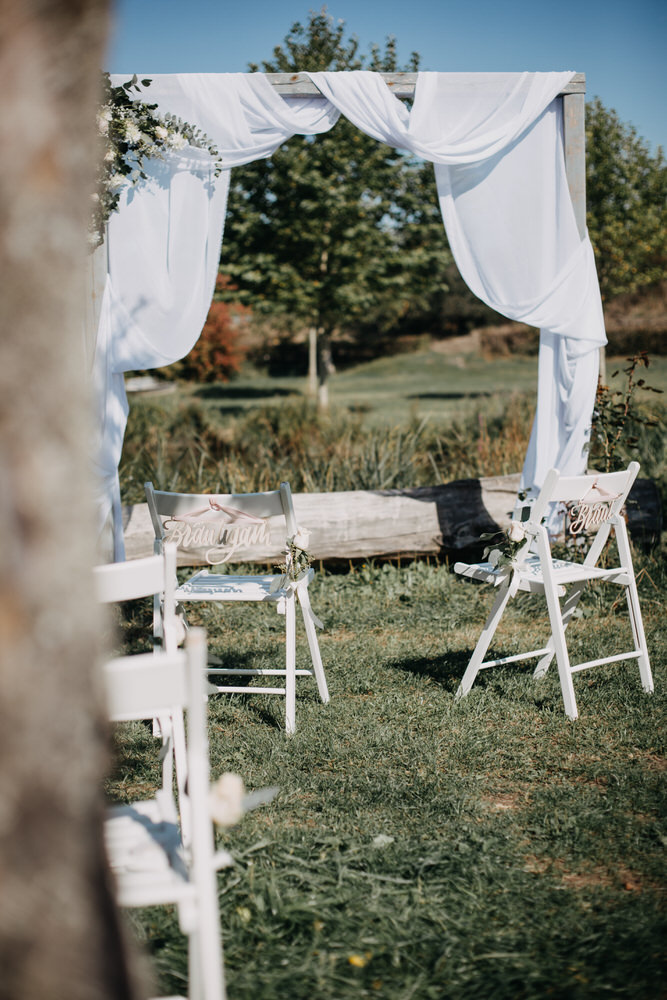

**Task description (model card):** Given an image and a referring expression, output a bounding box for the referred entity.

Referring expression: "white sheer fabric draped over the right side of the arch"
[309,72,606,489]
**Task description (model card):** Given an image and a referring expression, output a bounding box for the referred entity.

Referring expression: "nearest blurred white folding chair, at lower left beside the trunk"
[104,629,233,1000]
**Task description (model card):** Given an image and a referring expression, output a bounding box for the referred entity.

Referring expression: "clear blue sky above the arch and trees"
[105,0,667,151]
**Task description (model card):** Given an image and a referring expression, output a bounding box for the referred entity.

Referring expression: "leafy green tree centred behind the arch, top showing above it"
[221,9,451,404]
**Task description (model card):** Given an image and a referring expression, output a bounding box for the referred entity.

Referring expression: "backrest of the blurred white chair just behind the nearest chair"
[93,544,178,650]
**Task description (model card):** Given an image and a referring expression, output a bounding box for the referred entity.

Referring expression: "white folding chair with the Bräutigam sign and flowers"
[145,483,329,733]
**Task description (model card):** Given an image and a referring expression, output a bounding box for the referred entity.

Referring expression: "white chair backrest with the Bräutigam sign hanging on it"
[145,482,297,565]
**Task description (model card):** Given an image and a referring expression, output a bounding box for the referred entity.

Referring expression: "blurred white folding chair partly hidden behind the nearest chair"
[93,545,189,840]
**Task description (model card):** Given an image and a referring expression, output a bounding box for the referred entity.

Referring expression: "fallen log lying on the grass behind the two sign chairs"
[123,473,662,566]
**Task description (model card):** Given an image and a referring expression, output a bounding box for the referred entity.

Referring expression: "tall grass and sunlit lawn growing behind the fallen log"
[120,351,667,503]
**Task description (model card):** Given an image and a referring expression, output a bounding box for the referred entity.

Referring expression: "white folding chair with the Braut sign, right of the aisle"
[454,462,653,719]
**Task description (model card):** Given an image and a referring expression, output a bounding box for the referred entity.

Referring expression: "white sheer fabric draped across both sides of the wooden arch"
[95,71,605,559]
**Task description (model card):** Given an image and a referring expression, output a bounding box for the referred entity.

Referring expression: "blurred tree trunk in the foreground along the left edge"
[0,0,146,1000]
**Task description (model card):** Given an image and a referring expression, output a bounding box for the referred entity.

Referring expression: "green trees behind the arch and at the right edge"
[215,10,667,383]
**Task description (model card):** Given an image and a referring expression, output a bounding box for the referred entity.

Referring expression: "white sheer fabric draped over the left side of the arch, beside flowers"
[94,73,339,559]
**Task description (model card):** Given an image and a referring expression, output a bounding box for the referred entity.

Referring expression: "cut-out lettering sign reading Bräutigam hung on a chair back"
[164,500,271,566]
